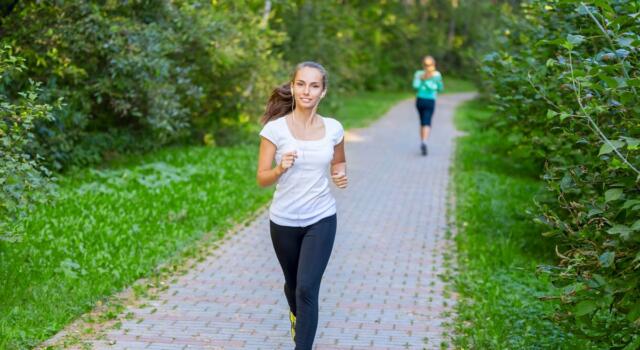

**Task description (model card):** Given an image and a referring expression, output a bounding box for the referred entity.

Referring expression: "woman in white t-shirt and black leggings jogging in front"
[256,62,347,350]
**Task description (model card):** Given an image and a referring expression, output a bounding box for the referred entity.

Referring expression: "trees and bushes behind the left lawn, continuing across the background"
[0,0,500,171]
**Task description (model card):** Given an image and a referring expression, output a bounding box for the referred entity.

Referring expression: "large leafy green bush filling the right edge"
[484,0,640,348]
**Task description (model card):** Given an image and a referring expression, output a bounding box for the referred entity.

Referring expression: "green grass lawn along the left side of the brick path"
[0,87,456,349]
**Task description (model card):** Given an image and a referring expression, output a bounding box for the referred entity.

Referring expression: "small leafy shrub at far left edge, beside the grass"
[0,45,53,241]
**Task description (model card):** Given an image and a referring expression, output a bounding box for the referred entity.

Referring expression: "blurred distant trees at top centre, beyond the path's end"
[272,0,509,91]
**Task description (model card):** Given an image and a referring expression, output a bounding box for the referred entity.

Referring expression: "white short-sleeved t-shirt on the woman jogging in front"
[260,117,344,227]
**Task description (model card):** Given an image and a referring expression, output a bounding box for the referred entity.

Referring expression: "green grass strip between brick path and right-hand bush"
[454,100,588,349]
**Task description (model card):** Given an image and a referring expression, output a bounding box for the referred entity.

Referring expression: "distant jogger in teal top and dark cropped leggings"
[413,56,444,156]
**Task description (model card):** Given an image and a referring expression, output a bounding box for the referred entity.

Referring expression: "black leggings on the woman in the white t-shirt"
[271,214,336,350]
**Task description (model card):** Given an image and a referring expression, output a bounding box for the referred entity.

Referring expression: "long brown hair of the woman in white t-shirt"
[260,61,328,124]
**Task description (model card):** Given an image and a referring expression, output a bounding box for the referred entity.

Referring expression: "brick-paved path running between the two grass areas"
[56,94,471,349]
